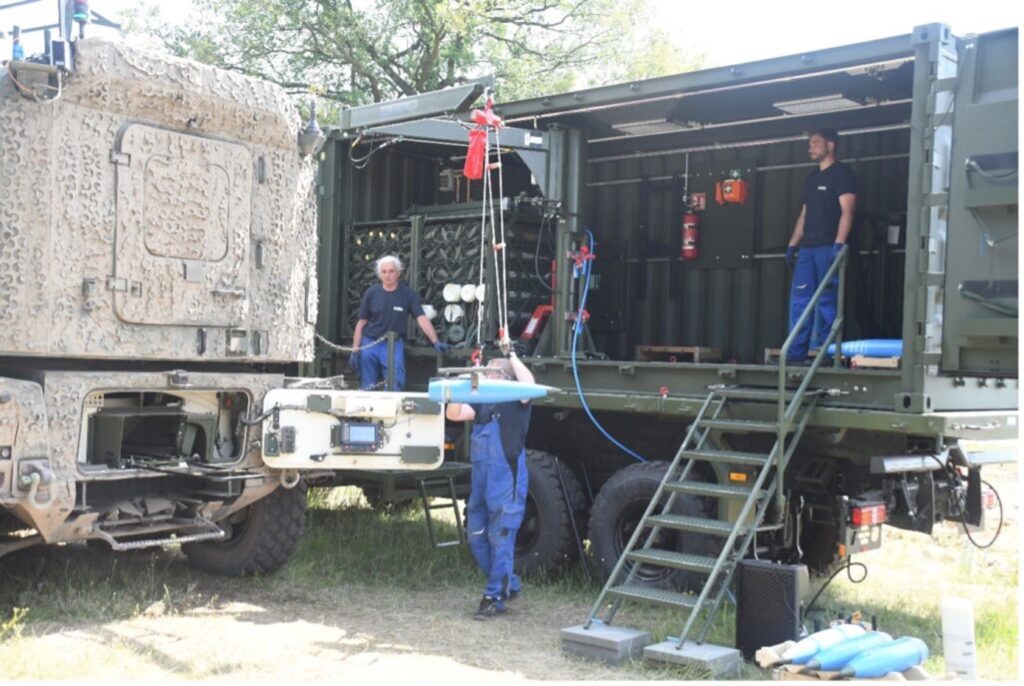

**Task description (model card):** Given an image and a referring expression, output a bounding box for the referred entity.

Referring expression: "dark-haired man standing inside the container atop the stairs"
[785,129,857,365]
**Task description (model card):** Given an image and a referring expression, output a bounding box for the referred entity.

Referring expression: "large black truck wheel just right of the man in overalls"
[515,451,587,577]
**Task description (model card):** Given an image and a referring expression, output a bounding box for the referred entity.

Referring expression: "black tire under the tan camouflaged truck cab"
[181,481,306,576]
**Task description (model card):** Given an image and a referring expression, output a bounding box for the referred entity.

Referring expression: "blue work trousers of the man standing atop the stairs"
[786,245,839,362]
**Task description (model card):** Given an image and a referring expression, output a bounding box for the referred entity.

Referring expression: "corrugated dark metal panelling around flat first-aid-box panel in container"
[586,129,909,361]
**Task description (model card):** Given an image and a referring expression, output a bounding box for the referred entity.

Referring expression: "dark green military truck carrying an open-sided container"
[315,25,1019,589]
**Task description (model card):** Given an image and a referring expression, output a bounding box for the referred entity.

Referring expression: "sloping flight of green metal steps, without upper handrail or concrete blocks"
[584,375,824,648]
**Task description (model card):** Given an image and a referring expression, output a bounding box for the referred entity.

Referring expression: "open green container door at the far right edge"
[942,29,1019,376]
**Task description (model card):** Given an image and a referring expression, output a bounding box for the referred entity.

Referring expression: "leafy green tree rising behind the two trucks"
[132,0,700,104]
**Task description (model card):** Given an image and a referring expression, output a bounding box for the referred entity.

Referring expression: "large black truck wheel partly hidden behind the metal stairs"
[589,462,720,591]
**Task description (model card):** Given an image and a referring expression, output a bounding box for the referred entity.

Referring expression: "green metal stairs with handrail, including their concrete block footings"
[563,246,849,671]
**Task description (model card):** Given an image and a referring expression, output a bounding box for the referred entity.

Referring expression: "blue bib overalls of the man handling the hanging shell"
[466,418,528,603]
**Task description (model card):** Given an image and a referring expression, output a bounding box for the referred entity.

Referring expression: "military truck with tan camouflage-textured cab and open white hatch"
[0,34,443,574]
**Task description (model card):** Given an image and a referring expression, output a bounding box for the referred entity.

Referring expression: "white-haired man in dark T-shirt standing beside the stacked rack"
[348,255,449,391]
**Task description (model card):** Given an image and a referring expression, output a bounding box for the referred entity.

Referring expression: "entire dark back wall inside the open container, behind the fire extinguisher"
[585,128,909,362]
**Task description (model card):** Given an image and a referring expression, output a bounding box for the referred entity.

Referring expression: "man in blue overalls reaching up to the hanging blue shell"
[445,352,534,619]
